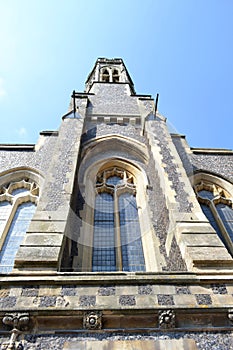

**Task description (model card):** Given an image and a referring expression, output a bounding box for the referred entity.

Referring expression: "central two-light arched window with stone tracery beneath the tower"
[92,168,145,271]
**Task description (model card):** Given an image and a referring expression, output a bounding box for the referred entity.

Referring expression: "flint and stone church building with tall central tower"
[0,58,233,350]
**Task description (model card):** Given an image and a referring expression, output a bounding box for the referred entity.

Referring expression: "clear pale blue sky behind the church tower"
[0,0,233,149]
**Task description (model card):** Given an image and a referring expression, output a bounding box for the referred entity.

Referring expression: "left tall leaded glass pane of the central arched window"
[92,193,116,271]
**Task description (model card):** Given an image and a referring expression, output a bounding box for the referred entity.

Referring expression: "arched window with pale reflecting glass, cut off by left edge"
[0,179,39,273]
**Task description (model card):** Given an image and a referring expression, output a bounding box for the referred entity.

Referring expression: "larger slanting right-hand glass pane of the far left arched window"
[0,202,35,273]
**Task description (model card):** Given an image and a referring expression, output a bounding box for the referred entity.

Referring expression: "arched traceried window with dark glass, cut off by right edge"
[195,181,233,254]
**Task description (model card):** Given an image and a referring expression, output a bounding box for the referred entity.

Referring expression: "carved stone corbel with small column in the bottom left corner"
[1,313,30,350]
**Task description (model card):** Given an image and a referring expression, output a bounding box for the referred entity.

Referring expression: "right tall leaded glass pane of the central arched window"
[119,193,145,271]
